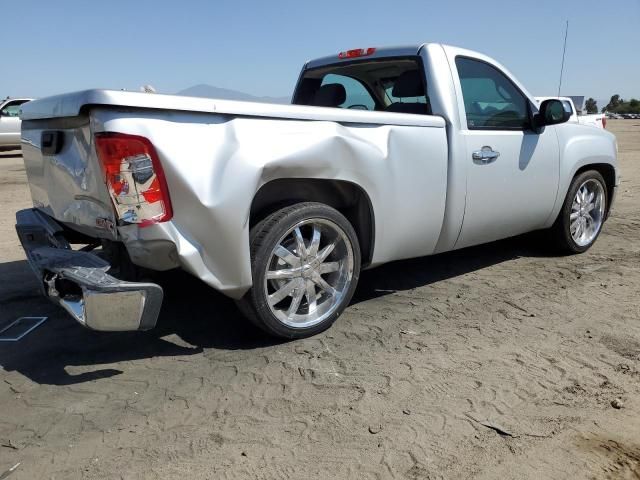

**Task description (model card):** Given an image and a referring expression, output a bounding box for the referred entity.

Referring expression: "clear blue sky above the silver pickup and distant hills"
[0,0,640,106]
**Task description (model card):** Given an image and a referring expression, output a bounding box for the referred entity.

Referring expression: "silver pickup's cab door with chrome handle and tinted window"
[455,56,559,248]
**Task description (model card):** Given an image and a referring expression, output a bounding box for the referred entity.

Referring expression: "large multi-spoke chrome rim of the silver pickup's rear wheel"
[264,218,354,328]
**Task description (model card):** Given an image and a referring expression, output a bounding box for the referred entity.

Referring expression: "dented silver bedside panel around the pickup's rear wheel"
[92,108,447,298]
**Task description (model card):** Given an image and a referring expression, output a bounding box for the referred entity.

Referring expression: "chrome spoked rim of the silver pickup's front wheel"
[569,179,605,247]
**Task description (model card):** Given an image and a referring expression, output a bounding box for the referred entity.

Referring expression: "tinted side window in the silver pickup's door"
[456,57,529,130]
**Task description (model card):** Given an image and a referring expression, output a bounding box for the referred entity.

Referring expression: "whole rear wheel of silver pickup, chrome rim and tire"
[239,203,360,338]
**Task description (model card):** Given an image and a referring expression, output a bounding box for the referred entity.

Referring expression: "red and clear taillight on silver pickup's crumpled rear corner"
[95,132,173,227]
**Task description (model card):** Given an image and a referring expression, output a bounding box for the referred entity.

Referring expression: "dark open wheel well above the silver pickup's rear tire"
[249,178,375,267]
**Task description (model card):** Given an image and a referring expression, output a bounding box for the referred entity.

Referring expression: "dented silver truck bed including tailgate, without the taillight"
[22,90,448,298]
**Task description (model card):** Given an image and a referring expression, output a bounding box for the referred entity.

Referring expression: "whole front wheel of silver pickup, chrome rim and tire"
[552,170,607,253]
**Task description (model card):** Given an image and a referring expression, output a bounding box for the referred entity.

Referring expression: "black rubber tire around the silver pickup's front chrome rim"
[551,170,609,254]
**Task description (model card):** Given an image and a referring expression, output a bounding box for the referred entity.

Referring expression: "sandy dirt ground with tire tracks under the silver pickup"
[0,120,640,480]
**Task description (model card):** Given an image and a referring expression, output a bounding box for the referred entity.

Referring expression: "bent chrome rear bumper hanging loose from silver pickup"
[16,209,163,331]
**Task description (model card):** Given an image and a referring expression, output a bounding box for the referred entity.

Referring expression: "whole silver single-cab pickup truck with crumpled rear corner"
[16,44,619,338]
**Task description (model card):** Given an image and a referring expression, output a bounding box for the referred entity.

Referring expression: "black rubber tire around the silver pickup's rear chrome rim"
[238,202,360,339]
